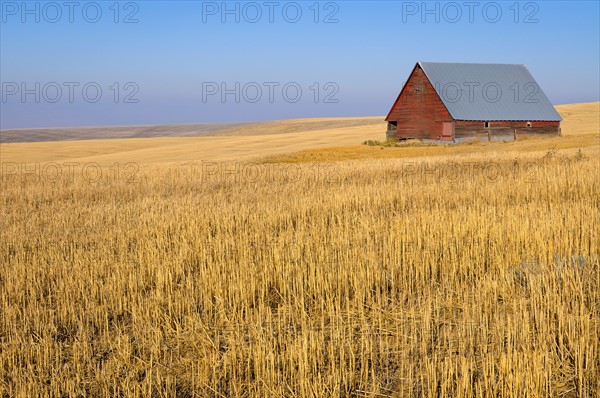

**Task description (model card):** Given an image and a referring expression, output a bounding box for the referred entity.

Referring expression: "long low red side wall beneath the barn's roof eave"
[454,120,560,139]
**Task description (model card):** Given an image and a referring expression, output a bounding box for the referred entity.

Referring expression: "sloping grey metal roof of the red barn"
[418,62,561,121]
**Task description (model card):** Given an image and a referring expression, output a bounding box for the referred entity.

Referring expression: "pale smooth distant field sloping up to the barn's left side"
[0,117,385,165]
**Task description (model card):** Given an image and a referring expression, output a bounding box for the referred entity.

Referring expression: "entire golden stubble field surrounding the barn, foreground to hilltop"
[0,103,600,397]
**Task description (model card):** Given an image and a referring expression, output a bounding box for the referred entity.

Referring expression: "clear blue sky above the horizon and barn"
[0,0,600,129]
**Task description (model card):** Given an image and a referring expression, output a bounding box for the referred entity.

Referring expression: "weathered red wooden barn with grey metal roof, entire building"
[385,62,562,141]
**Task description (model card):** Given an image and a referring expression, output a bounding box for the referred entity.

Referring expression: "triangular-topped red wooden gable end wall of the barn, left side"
[386,65,452,140]
